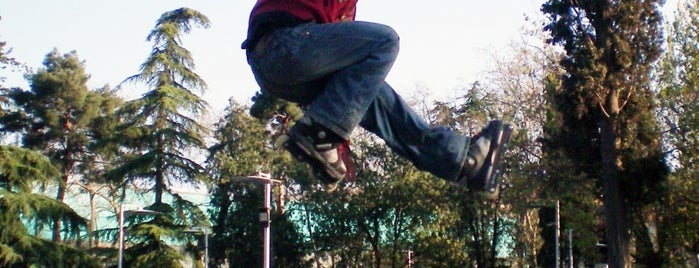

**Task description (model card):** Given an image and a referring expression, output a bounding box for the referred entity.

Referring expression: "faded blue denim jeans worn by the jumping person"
[248,22,470,180]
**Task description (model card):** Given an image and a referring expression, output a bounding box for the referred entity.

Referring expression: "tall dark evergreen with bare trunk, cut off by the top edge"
[542,0,666,268]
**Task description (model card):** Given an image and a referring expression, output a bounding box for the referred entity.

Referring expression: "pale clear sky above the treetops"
[0,0,677,110]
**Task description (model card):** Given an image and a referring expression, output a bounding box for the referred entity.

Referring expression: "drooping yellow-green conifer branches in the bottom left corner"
[0,146,98,267]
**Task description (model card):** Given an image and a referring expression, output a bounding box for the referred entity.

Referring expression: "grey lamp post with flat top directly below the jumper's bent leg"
[234,173,282,268]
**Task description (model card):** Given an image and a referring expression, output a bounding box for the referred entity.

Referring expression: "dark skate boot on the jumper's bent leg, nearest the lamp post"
[278,116,349,192]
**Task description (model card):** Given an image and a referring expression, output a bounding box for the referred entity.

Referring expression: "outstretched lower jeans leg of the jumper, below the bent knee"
[360,83,470,181]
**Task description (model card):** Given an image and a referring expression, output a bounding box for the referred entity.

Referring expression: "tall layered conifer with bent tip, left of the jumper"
[108,8,209,267]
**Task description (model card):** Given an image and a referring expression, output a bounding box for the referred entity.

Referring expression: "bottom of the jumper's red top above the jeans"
[250,0,357,23]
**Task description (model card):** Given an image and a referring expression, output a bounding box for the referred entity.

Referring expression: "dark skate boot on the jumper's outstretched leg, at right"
[458,120,515,199]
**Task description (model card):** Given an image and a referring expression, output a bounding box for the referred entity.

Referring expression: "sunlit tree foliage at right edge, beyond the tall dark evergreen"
[649,0,699,266]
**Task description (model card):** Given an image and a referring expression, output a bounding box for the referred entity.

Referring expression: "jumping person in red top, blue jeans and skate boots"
[242,0,513,193]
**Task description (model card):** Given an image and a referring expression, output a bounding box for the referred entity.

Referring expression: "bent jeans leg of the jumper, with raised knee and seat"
[248,22,399,139]
